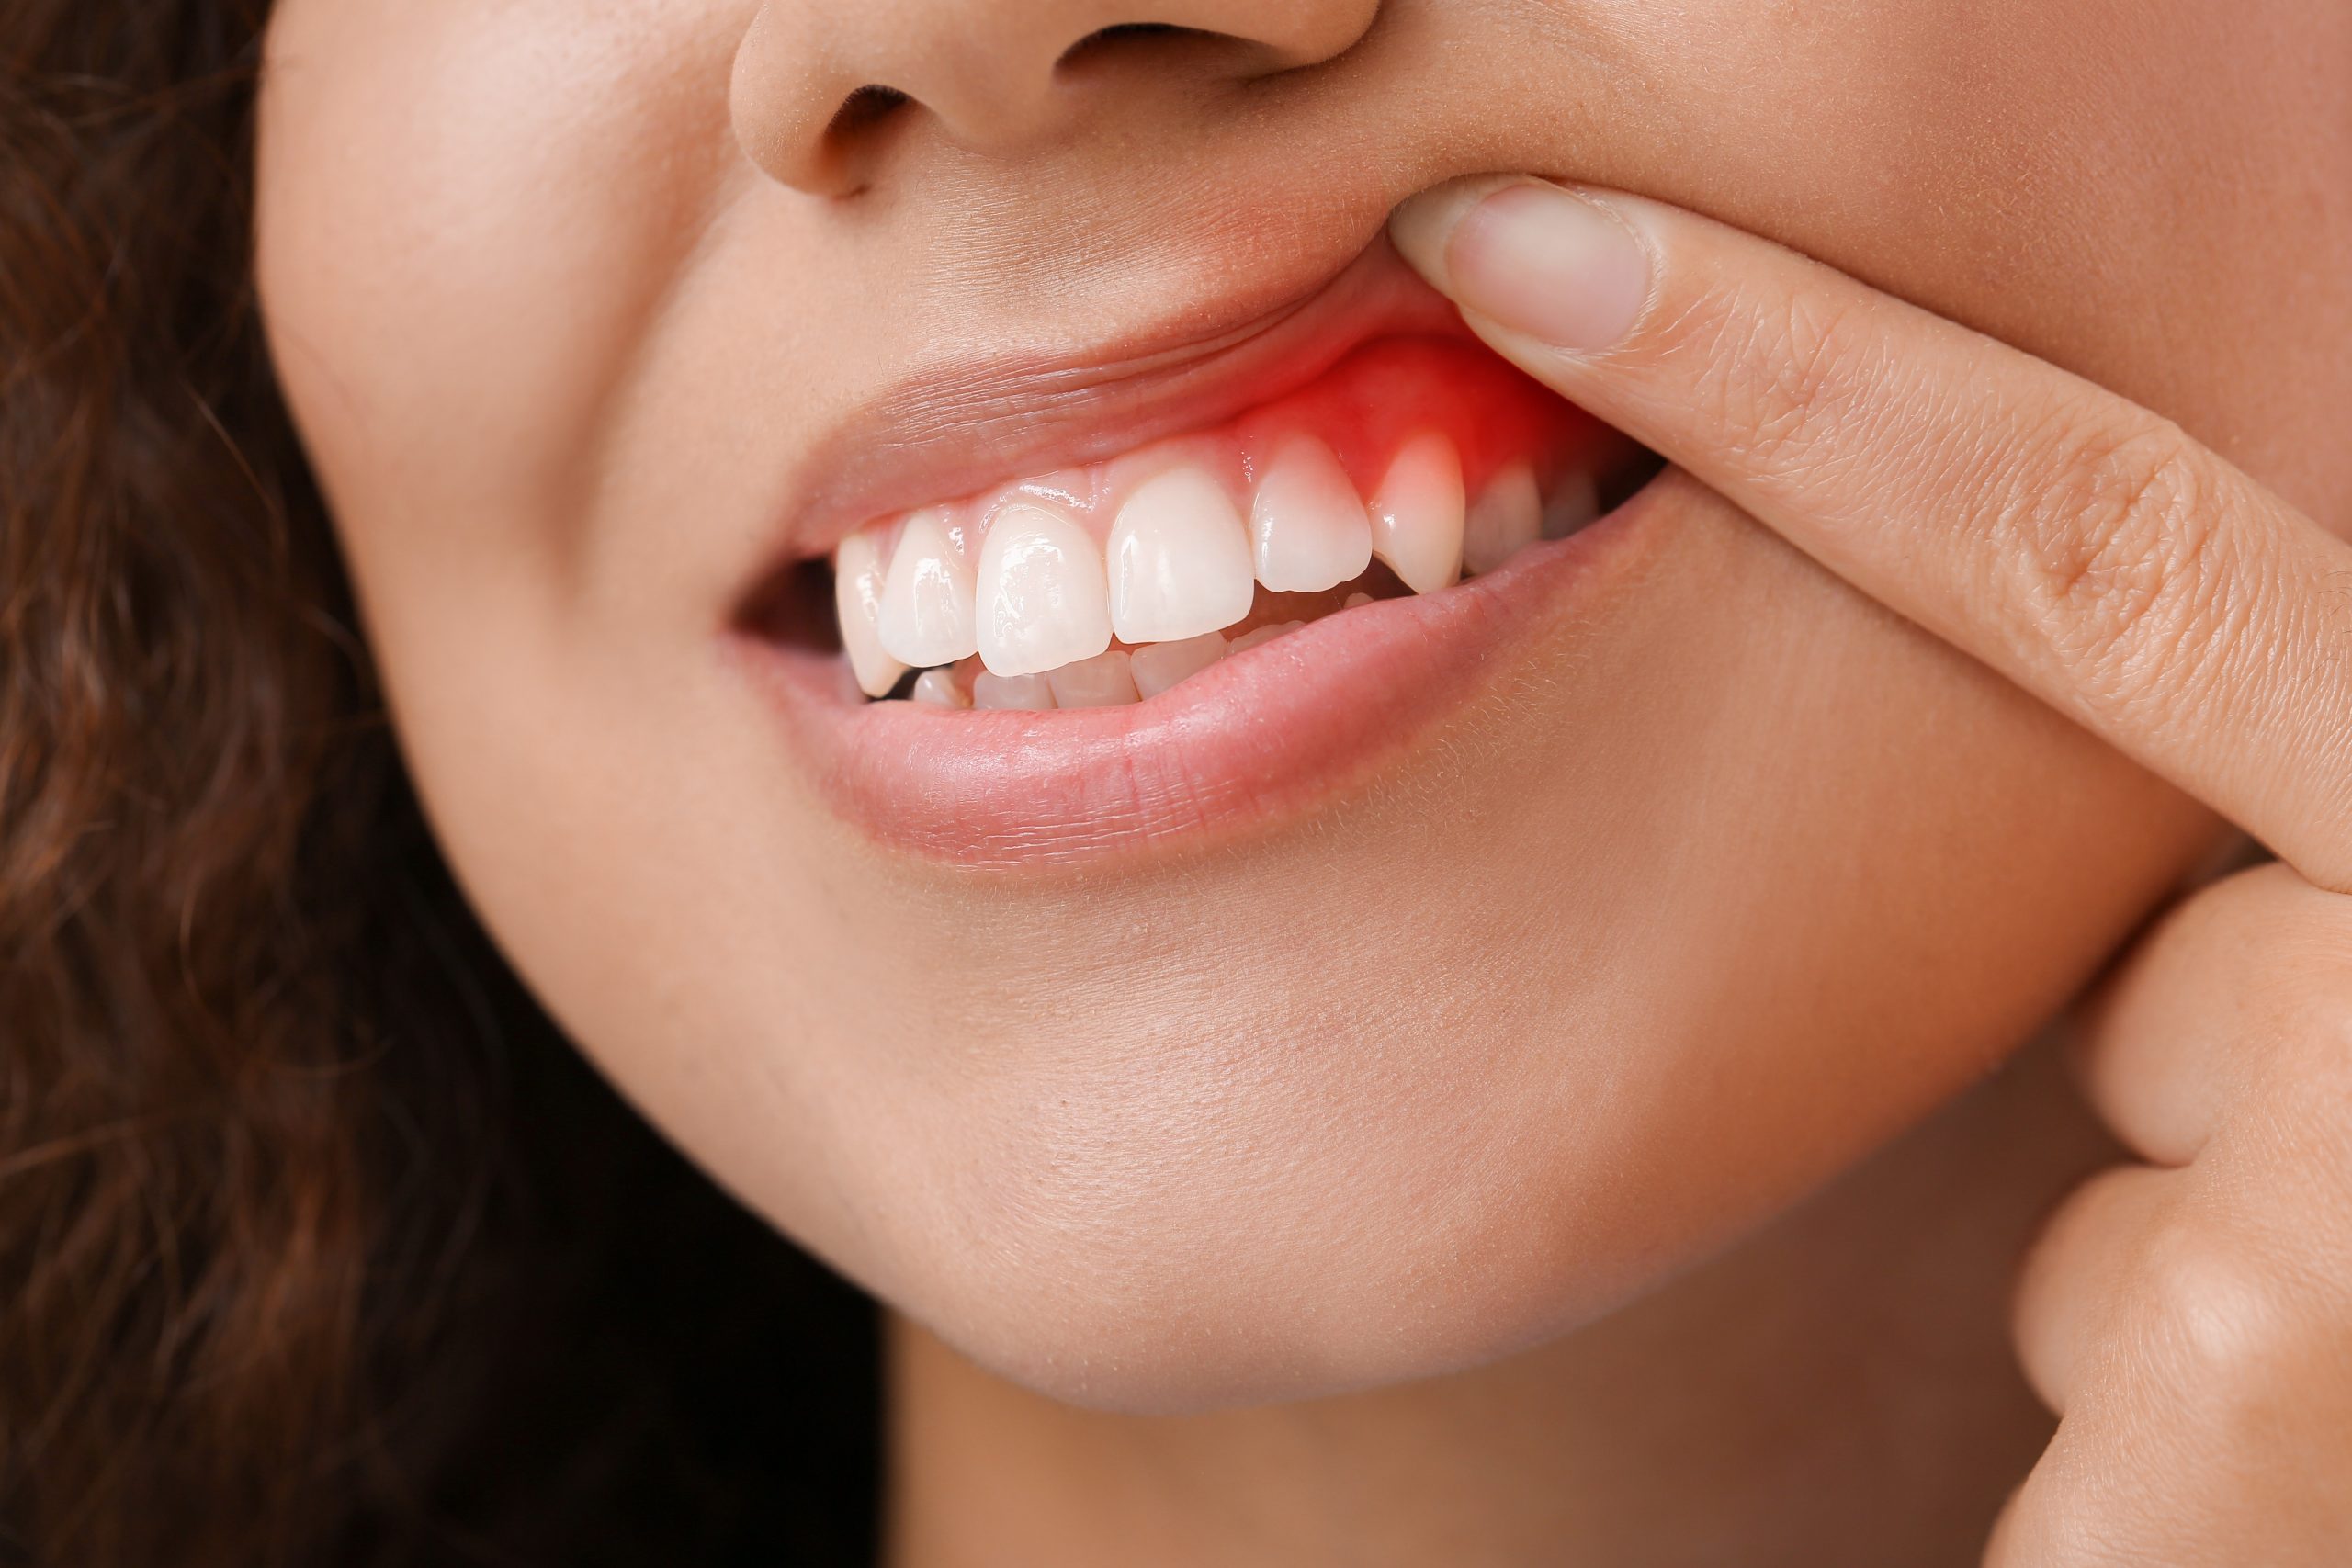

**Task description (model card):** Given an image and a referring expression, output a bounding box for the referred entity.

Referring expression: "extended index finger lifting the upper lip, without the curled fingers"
[1390,179,2352,891]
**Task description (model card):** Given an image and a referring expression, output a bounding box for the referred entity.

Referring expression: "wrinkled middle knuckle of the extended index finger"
[2002,404,2232,724]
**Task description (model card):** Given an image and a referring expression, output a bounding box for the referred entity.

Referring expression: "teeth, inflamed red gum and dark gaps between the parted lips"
[755,336,1663,710]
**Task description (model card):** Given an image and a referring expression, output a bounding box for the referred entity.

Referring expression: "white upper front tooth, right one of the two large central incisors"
[1110,463,1259,642]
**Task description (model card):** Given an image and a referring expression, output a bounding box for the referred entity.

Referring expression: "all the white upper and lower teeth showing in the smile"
[832,430,1600,707]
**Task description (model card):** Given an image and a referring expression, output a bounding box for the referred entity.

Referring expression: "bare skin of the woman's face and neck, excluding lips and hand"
[259,0,2352,1561]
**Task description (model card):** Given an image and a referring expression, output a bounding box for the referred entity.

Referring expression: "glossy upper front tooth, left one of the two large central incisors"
[978,501,1110,674]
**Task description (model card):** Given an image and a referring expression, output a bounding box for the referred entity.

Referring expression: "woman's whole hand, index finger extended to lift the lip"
[1393,179,2352,1568]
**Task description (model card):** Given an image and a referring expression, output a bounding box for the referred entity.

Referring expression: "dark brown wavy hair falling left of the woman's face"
[0,0,875,1568]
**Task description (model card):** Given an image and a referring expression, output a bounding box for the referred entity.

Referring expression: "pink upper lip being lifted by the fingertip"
[729,231,1465,602]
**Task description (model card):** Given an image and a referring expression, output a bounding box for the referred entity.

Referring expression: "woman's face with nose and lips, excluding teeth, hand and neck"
[261,0,2352,1408]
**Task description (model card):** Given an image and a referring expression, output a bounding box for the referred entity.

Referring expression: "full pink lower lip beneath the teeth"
[727,479,1663,867]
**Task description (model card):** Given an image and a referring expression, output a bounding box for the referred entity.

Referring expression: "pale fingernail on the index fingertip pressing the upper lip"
[1393,181,1649,353]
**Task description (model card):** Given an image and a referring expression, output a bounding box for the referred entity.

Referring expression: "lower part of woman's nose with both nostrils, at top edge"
[731,0,1381,195]
